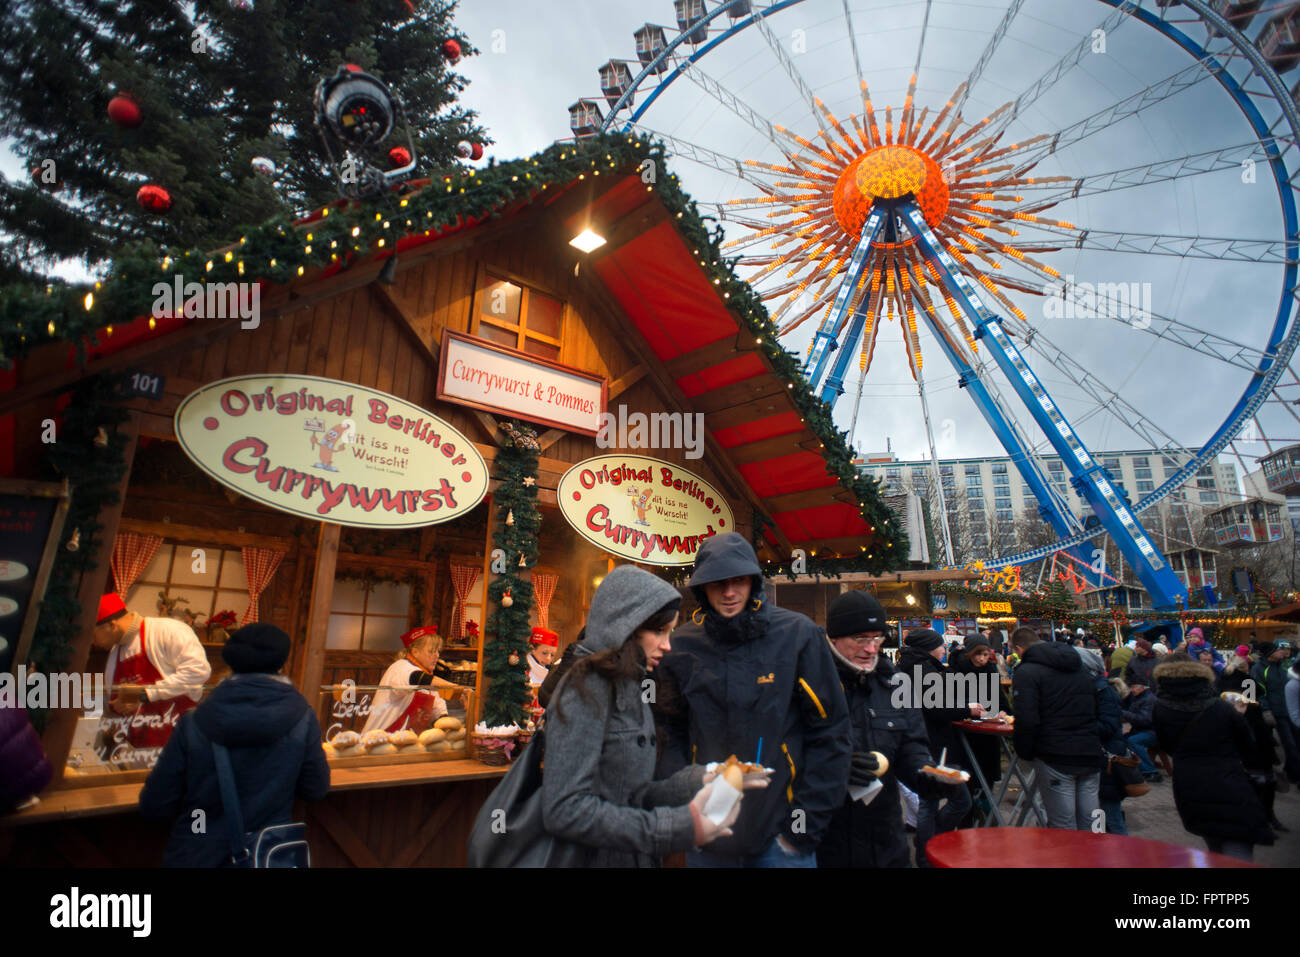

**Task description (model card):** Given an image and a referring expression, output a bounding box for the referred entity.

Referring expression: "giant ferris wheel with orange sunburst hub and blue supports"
[569,0,1300,609]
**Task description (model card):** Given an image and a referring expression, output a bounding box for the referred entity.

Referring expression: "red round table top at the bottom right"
[926,827,1256,867]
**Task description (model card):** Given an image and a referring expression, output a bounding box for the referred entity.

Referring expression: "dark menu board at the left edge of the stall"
[0,481,68,671]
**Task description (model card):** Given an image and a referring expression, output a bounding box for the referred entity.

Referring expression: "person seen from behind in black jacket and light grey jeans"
[1011,628,1101,831]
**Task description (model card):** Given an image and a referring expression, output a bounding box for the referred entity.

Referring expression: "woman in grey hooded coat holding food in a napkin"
[542,566,740,867]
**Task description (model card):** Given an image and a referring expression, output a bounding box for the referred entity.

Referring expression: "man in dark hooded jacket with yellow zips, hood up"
[655,532,852,867]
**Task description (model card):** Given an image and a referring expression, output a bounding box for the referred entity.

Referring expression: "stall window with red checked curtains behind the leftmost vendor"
[126,542,248,622]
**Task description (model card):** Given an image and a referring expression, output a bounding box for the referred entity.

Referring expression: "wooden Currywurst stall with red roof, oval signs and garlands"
[0,140,906,866]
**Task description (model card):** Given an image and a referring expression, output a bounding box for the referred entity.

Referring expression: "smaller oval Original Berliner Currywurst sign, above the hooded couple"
[556,455,736,566]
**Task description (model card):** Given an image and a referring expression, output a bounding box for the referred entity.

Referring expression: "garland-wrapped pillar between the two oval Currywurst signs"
[482,421,542,727]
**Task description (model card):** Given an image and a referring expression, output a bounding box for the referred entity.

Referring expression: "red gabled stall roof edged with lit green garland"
[0,135,906,568]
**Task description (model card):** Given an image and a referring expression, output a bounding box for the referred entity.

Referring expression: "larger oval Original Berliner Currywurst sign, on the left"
[176,376,488,528]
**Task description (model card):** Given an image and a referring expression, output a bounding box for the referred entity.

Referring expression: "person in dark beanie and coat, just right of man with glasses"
[898,628,985,867]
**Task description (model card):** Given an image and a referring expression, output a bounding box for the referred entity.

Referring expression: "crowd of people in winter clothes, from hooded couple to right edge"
[504,534,1300,867]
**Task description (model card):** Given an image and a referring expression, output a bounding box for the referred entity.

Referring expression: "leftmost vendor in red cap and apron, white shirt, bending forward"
[91,593,212,749]
